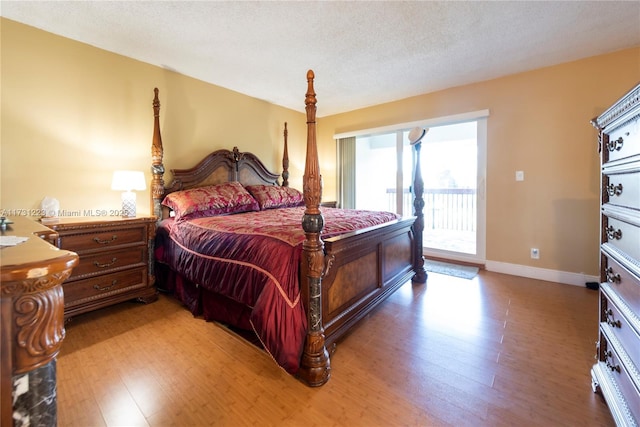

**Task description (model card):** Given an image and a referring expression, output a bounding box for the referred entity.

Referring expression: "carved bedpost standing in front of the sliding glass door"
[409,128,428,284]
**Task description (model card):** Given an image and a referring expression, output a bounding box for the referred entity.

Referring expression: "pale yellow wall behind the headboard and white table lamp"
[0,18,306,214]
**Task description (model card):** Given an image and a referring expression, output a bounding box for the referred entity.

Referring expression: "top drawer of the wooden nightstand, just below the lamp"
[58,227,147,252]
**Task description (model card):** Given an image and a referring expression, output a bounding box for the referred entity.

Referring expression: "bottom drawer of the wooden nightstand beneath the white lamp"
[63,268,148,310]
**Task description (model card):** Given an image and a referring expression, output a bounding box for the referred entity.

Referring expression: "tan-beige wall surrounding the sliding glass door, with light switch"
[316,48,640,275]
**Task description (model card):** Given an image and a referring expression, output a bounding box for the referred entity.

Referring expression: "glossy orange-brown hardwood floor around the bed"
[57,271,614,427]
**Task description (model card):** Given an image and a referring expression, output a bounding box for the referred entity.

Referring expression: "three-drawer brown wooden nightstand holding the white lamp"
[47,217,158,318]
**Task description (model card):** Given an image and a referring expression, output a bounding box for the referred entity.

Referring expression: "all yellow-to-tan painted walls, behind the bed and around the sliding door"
[0,18,640,275]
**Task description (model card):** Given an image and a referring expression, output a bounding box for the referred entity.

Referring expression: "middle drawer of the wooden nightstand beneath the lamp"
[69,246,147,280]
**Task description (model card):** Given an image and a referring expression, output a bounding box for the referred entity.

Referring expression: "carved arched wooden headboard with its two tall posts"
[151,88,289,219]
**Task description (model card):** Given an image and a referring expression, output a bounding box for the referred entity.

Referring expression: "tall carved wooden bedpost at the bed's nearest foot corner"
[298,70,331,386]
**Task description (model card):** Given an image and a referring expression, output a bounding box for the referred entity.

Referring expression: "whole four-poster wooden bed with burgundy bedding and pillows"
[151,70,427,386]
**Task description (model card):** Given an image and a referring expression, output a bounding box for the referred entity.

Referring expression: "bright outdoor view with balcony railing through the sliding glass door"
[339,118,486,261]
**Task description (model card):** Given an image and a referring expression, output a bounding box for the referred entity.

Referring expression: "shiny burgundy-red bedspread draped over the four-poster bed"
[156,207,398,374]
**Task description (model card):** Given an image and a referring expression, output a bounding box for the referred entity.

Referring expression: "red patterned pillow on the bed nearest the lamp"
[162,182,260,220]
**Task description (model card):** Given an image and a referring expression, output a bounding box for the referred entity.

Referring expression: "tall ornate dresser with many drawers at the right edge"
[591,85,640,426]
